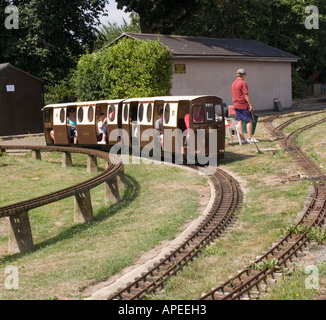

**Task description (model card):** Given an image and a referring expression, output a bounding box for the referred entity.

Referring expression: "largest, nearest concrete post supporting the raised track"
[9,211,34,253]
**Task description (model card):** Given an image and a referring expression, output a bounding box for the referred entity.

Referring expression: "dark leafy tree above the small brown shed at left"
[0,0,108,84]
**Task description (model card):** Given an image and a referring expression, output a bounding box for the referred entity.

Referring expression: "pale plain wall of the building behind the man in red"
[171,58,292,111]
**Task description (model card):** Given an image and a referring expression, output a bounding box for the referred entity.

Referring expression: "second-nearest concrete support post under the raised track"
[74,190,93,222]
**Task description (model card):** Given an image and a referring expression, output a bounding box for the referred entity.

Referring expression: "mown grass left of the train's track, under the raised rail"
[0,154,210,299]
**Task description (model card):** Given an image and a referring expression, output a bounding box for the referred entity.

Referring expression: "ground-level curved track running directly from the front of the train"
[107,169,242,300]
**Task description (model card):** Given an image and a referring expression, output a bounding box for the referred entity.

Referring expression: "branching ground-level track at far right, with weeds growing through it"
[200,113,326,300]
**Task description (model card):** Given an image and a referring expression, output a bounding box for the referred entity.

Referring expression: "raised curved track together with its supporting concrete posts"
[0,145,124,253]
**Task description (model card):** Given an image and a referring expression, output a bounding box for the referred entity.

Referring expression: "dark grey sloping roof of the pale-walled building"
[116,32,299,61]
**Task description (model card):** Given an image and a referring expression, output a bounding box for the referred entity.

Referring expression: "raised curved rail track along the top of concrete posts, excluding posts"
[0,146,123,217]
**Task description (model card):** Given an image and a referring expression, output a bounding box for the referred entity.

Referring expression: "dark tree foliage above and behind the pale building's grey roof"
[117,0,326,78]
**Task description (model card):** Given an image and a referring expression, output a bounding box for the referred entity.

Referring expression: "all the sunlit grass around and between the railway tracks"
[0,110,326,300]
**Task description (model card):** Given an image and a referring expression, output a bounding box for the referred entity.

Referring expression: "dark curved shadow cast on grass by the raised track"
[0,175,140,263]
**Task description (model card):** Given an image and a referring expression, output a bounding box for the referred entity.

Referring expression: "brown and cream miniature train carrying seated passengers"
[43,96,225,158]
